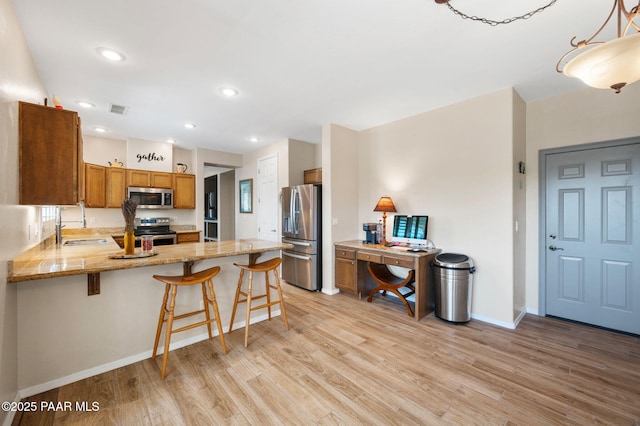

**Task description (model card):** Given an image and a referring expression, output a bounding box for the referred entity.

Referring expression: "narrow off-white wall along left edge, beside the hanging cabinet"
[0,0,47,424]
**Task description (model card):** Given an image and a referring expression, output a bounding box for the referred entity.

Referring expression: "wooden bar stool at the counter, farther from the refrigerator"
[151,266,227,379]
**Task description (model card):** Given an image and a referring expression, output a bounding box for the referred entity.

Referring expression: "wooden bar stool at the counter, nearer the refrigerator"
[229,257,289,348]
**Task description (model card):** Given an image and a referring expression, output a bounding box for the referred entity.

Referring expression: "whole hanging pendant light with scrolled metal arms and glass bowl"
[556,0,640,93]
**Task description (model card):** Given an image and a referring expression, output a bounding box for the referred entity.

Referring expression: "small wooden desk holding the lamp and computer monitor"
[335,240,440,321]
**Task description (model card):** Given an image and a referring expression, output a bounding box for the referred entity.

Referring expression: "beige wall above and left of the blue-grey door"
[526,83,640,312]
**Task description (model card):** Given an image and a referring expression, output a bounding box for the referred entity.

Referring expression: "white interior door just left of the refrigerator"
[257,154,280,241]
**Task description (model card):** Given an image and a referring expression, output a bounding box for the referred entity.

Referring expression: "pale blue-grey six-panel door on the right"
[545,144,640,334]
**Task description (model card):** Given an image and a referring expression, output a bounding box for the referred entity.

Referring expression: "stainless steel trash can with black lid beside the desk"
[431,253,476,322]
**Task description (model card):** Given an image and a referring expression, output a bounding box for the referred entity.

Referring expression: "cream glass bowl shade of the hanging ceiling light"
[563,33,640,91]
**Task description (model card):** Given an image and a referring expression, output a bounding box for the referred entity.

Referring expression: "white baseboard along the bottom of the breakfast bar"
[16,310,280,400]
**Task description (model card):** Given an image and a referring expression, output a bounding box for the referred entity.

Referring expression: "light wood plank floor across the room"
[14,285,640,425]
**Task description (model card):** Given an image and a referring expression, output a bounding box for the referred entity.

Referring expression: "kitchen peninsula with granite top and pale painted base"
[7,234,289,395]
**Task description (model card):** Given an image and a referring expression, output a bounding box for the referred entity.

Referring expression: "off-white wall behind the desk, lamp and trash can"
[357,89,515,325]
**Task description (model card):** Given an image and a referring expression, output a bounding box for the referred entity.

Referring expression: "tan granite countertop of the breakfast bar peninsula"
[7,236,292,282]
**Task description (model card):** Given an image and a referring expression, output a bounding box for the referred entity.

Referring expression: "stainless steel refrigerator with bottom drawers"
[282,185,322,291]
